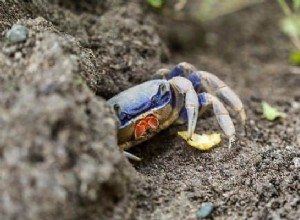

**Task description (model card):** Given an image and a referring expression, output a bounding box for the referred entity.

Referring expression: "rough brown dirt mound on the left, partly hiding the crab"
[0,1,163,219]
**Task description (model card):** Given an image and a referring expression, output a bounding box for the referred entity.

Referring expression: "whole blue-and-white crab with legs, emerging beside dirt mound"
[108,62,246,160]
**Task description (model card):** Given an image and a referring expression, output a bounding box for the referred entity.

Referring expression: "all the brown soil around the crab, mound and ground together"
[0,0,300,219]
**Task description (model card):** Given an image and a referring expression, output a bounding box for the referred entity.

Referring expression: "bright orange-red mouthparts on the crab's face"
[134,115,159,138]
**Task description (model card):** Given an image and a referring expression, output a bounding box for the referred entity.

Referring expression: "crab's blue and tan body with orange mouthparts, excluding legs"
[108,80,179,149]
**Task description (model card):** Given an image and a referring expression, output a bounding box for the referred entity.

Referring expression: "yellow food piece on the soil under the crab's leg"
[177,131,221,150]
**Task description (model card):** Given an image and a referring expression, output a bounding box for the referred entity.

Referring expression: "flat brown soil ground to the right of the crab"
[133,2,300,219]
